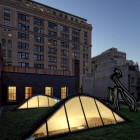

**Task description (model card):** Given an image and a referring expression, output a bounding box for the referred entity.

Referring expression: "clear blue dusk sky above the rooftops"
[34,0,140,65]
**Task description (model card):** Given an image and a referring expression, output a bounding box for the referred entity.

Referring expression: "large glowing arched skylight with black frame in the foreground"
[26,94,126,138]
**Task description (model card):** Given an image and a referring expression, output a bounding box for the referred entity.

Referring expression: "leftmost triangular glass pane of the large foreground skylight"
[32,123,47,138]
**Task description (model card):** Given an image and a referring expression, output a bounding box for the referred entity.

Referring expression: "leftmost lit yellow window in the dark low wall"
[8,86,16,101]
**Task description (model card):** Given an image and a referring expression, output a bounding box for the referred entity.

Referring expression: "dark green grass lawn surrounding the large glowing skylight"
[0,107,140,140]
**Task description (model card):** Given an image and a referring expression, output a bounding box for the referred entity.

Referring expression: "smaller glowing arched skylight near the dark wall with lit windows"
[17,95,59,109]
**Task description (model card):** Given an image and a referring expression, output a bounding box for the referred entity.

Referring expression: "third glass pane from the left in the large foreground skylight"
[66,97,87,131]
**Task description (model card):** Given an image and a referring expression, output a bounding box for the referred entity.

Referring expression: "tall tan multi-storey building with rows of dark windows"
[0,0,92,91]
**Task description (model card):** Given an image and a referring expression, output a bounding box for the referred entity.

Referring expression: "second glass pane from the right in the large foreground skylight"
[95,100,116,125]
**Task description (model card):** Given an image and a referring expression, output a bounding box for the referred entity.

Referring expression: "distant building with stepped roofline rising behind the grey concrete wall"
[91,48,127,72]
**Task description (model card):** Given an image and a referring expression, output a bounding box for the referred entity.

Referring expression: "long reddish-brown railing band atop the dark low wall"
[2,66,71,76]
